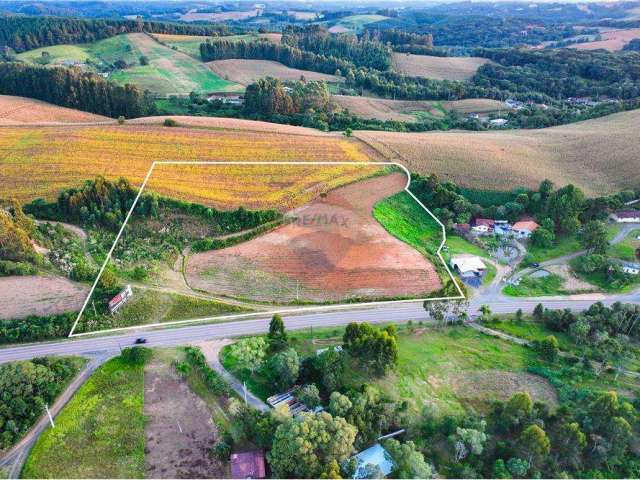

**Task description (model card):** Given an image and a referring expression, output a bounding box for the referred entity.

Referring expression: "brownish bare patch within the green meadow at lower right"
[448,370,558,408]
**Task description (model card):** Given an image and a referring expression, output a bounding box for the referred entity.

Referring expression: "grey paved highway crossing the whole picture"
[0,292,640,363]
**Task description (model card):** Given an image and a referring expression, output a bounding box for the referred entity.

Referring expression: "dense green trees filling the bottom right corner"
[420,392,638,478]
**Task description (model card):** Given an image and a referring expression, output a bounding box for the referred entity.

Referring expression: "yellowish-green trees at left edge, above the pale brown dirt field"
[0,201,42,276]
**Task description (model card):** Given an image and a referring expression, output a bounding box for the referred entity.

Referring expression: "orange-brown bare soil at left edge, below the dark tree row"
[0,95,111,126]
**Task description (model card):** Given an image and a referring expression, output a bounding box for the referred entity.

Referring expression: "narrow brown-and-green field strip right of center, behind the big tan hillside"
[331,95,506,122]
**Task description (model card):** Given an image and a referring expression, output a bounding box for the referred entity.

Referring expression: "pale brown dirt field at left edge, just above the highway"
[0,276,89,320]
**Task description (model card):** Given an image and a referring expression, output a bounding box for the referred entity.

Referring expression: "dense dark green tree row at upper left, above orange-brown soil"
[0,62,154,118]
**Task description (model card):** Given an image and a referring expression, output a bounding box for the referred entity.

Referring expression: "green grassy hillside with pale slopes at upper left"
[18,33,242,96]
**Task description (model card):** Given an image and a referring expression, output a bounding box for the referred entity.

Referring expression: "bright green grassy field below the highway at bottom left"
[22,357,145,478]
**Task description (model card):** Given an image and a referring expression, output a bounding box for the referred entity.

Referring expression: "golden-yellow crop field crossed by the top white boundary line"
[0,125,371,209]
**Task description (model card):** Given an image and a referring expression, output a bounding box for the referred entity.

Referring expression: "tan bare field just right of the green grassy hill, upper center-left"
[207,58,342,85]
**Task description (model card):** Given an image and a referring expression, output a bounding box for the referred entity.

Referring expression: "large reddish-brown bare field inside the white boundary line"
[186,173,441,302]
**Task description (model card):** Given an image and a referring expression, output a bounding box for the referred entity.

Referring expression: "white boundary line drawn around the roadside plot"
[69,160,466,338]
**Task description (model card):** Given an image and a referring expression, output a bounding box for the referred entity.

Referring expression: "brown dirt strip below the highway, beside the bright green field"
[144,351,229,478]
